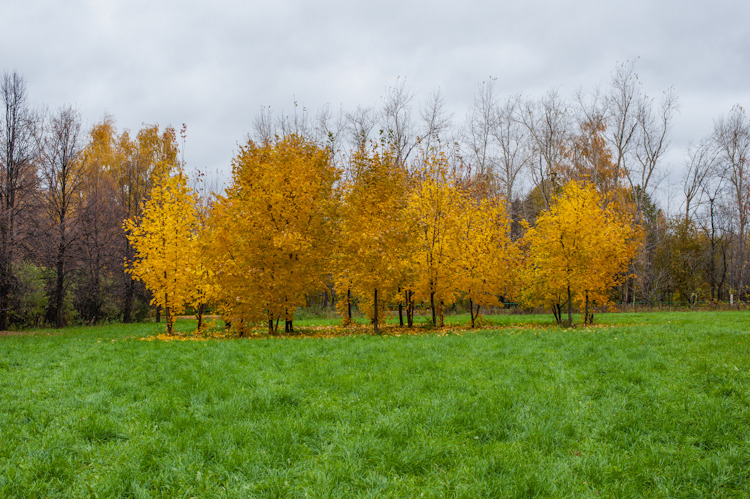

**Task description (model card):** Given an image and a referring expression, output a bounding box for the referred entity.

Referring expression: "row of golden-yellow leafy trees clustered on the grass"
[126,134,640,333]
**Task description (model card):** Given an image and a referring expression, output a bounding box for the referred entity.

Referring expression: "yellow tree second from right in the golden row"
[456,195,520,327]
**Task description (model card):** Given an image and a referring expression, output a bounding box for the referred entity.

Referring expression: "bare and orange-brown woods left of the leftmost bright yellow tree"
[0,73,188,330]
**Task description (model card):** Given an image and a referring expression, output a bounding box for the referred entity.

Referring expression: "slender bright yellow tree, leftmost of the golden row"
[125,170,203,333]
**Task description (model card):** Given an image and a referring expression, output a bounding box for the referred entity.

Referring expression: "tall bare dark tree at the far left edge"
[0,73,37,330]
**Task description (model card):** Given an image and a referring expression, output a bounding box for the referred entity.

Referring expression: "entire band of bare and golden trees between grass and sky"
[0,64,750,329]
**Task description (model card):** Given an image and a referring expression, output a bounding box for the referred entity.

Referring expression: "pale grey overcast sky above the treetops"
[0,0,750,203]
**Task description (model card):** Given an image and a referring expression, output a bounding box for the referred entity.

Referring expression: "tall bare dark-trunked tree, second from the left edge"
[39,107,84,328]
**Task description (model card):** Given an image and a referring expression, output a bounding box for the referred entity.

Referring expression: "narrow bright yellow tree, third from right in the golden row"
[409,154,468,326]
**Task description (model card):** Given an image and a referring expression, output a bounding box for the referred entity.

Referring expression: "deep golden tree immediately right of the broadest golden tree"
[334,144,411,332]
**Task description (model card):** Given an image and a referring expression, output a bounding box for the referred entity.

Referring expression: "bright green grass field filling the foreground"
[0,312,750,498]
